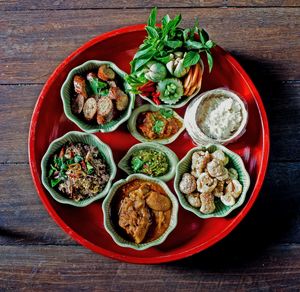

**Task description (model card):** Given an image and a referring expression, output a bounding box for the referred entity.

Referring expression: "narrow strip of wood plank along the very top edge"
[0,0,299,11]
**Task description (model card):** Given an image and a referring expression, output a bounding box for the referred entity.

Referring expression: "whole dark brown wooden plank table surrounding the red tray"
[0,0,300,291]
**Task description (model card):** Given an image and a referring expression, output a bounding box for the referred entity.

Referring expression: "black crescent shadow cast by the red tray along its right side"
[169,55,300,272]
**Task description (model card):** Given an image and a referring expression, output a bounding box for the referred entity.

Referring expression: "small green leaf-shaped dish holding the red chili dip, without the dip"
[127,104,185,145]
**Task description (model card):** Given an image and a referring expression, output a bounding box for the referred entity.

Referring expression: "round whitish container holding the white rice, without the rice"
[184,88,248,145]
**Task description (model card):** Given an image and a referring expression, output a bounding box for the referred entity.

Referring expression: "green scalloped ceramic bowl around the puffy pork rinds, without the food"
[174,144,250,218]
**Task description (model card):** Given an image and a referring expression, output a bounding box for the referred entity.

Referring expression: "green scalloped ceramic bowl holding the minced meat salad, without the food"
[41,131,117,207]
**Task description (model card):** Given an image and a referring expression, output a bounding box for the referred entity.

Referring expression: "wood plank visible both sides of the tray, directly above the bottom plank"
[0,162,300,245]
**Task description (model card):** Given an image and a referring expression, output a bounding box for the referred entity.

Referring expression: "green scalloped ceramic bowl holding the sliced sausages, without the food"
[60,60,135,133]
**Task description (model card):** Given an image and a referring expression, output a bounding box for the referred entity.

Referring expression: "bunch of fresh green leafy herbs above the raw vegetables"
[126,7,215,93]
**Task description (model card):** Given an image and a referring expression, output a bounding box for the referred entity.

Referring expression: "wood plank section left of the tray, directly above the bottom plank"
[0,164,74,245]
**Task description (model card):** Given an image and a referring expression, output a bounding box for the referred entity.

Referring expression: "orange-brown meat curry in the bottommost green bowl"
[111,179,172,244]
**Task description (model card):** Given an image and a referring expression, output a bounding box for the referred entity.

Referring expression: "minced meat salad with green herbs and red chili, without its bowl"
[48,142,109,201]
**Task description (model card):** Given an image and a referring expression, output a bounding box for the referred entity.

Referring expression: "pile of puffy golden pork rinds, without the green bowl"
[179,150,243,214]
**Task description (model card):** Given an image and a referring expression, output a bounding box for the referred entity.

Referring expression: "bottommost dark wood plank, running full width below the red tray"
[0,245,300,291]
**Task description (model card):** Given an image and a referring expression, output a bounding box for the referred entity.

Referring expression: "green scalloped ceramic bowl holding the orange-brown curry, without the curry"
[102,174,178,250]
